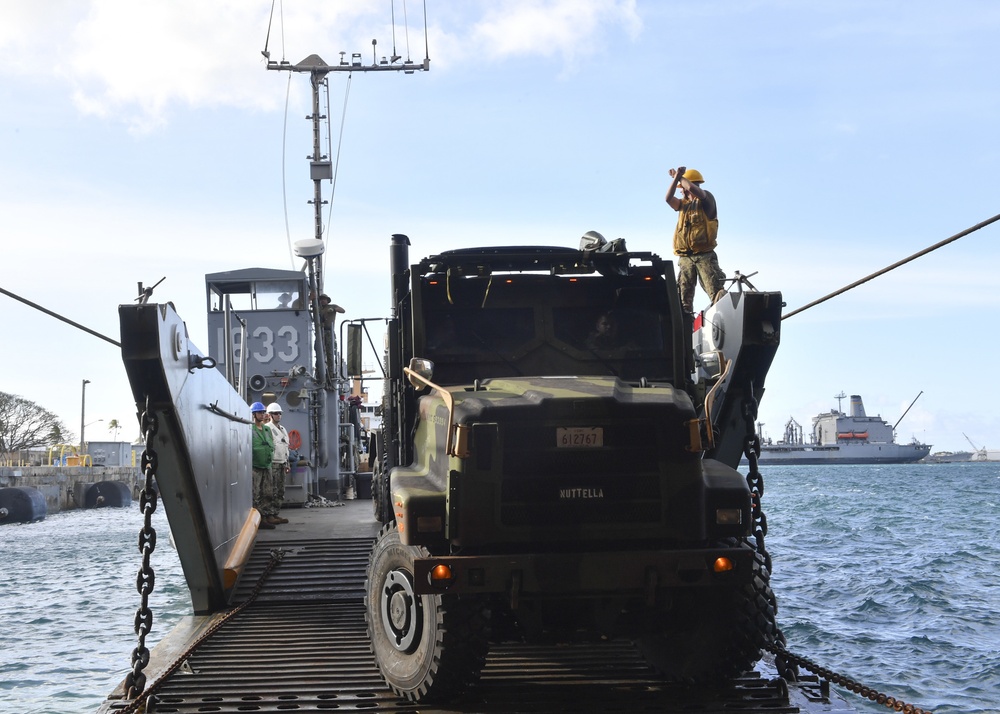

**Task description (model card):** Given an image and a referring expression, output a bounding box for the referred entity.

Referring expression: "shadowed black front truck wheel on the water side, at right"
[637,541,777,682]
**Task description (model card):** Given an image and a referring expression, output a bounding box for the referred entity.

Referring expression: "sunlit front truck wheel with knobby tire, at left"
[365,523,489,702]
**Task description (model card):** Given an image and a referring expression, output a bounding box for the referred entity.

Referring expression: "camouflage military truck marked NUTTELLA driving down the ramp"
[364,235,780,701]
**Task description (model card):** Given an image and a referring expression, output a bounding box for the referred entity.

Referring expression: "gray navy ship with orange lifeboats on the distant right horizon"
[759,393,931,464]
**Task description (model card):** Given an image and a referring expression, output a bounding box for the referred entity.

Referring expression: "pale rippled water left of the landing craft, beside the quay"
[0,504,191,714]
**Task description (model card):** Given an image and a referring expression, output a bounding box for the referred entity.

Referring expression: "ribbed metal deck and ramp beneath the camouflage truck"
[102,501,854,714]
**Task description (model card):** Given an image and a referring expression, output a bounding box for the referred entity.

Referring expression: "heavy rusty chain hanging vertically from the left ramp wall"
[125,395,159,699]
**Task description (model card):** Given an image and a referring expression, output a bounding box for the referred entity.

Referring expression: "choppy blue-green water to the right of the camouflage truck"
[762,463,1000,714]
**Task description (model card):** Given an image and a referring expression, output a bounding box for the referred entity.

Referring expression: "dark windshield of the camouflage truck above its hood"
[414,273,673,385]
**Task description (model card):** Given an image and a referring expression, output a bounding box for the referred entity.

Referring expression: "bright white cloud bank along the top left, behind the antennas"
[0,0,641,132]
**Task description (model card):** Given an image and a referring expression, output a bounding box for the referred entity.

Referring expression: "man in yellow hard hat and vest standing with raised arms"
[666,166,726,313]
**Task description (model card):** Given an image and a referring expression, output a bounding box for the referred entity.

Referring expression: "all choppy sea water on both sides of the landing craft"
[0,463,1000,714]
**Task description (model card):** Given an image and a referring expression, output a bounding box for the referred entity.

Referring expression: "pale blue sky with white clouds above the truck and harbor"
[0,0,1000,451]
